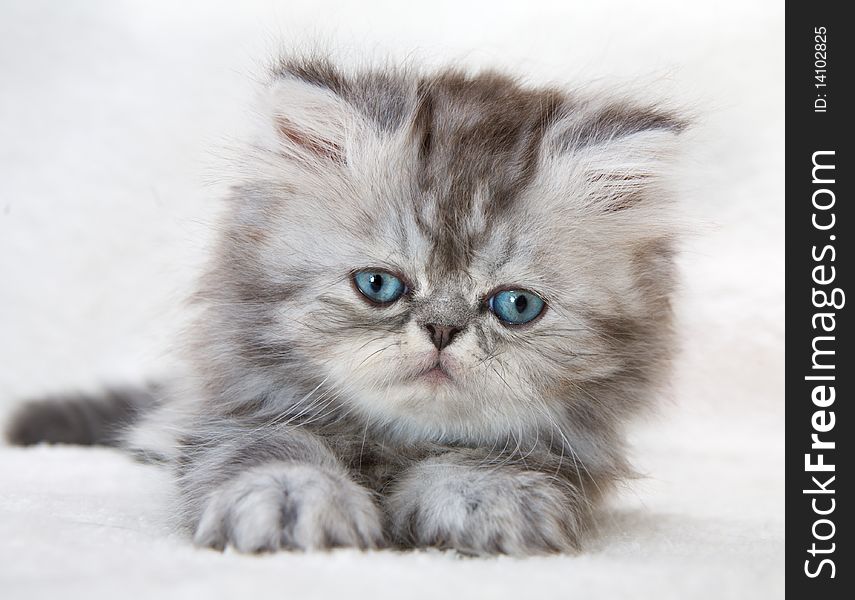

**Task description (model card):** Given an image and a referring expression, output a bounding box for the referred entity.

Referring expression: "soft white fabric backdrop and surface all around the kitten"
[0,0,784,599]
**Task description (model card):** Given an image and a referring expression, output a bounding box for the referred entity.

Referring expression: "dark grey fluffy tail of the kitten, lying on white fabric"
[6,385,159,446]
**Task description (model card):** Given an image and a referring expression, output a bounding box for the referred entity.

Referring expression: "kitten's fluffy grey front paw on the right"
[388,461,579,556]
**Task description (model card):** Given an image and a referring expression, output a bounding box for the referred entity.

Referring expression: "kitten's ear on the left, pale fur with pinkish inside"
[268,75,356,162]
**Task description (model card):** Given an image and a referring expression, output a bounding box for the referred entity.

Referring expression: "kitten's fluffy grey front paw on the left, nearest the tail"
[194,462,383,552]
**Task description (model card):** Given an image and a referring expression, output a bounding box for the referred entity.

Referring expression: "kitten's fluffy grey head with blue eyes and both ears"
[201,62,682,442]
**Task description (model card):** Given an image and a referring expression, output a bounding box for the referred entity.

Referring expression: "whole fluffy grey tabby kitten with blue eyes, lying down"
[9,59,684,555]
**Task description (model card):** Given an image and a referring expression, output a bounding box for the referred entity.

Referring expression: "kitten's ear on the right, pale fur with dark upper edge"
[548,104,687,212]
